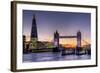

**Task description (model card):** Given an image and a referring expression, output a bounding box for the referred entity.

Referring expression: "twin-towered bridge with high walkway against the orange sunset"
[54,30,81,54]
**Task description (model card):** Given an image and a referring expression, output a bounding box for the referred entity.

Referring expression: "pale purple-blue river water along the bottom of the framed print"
[23,52,91,62]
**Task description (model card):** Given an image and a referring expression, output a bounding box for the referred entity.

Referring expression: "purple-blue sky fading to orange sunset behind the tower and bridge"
[23,10,91,45]
